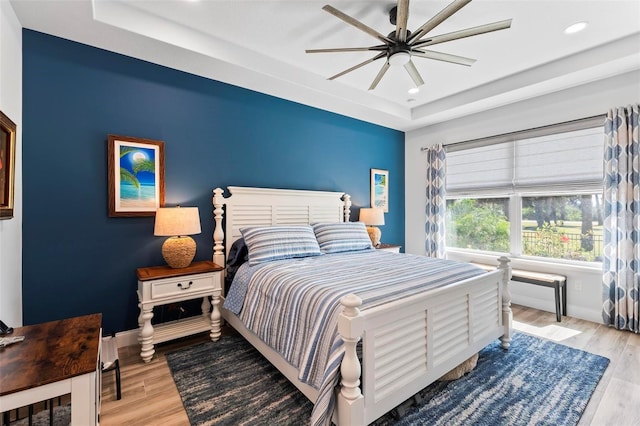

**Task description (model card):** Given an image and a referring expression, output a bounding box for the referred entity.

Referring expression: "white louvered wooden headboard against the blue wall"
[213,186,351,266]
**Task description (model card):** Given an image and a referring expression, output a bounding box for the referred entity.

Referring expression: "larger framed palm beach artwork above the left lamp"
[107,135,164,217]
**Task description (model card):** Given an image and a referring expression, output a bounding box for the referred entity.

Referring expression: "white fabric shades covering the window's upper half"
[446,126,604,196]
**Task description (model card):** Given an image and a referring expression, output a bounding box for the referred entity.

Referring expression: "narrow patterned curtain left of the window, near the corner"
[425,145,446,259]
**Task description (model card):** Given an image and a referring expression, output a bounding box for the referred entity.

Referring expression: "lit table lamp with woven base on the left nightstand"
[153,206,201,268]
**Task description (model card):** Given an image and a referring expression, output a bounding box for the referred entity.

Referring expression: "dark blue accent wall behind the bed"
[22,29,404,331]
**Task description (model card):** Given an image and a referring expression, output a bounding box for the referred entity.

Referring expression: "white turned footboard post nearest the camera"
[338,294,364,425]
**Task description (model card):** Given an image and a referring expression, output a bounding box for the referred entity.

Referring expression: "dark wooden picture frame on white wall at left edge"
[0,111,17,219]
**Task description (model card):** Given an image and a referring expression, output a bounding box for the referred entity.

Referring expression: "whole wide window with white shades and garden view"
[446,119,603,262]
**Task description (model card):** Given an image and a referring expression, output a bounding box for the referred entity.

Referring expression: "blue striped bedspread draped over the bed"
[224,250,484,424]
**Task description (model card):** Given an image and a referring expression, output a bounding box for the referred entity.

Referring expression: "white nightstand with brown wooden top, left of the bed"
[137,261,224,362]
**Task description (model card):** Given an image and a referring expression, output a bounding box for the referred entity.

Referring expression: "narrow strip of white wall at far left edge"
[0,0,22,327]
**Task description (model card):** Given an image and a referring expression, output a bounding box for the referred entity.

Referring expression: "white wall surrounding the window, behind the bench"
[405,71,640,322]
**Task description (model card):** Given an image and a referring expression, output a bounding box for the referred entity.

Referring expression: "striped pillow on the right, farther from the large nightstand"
[313,222,373,253]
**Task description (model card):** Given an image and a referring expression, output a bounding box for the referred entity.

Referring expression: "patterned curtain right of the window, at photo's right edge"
[602,105,640,333]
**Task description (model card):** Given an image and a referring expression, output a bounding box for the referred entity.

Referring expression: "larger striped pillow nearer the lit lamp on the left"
[240,225,322,266]
